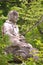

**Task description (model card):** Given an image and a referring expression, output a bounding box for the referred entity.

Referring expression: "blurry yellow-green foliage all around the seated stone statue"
[0,0,43,65]
